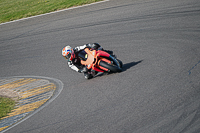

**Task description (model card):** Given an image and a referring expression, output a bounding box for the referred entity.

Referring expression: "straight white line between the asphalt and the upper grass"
[0,0,110,25]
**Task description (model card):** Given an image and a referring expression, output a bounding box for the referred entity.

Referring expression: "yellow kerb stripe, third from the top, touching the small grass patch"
[3,99,48,119]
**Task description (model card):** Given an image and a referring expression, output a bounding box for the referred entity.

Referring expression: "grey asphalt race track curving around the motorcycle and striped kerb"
[0,0,200,133]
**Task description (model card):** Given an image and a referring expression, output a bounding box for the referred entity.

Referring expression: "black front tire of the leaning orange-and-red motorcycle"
[99,61,122,72]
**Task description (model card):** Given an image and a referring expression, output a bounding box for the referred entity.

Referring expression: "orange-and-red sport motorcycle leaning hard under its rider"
[78,48,123,73]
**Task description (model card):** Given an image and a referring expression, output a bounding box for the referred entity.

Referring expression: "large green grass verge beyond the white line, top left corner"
[0,0,101,23]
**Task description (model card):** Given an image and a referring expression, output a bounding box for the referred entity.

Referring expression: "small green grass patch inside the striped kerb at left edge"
[0,97,15,119]
